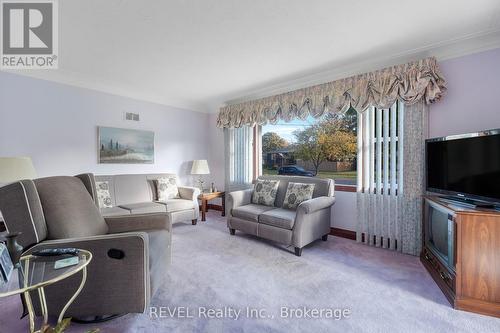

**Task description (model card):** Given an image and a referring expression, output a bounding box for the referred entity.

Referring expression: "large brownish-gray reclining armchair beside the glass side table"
[0,174,171,318]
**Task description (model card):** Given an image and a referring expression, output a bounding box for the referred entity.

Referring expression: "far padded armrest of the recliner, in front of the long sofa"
[104,213,172,233]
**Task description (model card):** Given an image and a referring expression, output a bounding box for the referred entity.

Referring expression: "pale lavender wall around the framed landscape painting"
[0,72,208,183]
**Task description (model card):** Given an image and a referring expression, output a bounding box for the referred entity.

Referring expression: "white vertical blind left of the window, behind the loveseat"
[224,126,254,191]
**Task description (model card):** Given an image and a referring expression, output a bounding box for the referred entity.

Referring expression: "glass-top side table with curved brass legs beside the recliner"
[0,250,92,332]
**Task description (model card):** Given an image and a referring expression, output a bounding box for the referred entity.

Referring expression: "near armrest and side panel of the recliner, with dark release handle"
[25,232,151,318]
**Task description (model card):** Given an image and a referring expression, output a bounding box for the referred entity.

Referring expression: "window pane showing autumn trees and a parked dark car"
[261,108,358,185]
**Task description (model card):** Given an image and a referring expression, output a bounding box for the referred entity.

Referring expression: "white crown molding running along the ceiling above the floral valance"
[214,30,500,112]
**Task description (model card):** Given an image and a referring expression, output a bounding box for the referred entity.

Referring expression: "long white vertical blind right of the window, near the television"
[357,102,404,250]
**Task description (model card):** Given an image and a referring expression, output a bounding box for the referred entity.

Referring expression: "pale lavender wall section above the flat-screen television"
[429,49,500,137]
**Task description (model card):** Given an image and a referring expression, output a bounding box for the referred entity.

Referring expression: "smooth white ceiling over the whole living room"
[6,0,500,112]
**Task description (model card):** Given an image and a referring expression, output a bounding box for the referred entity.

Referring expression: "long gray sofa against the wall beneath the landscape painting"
[95,173,200,225]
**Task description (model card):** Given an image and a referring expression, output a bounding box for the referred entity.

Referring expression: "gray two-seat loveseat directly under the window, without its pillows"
[227,176,335,256]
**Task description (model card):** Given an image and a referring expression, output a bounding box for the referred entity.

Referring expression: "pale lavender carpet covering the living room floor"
[0,212,500,333]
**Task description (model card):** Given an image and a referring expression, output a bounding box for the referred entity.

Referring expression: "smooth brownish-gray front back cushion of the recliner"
[35,176,108,239]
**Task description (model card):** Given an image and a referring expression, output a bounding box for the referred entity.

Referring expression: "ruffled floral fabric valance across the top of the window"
[217,57,446,128]
